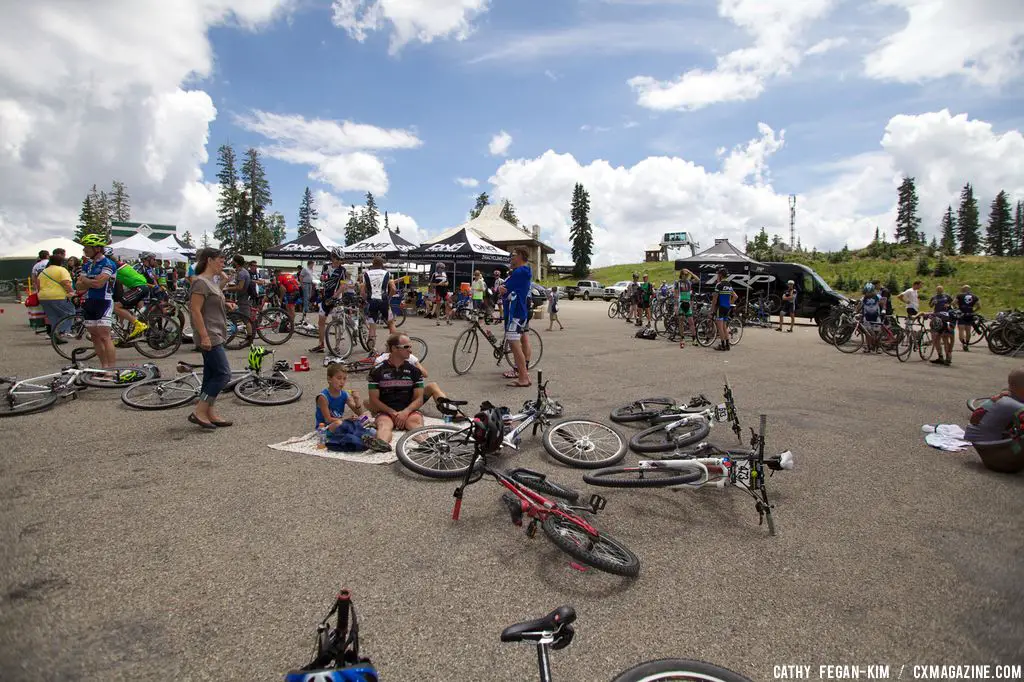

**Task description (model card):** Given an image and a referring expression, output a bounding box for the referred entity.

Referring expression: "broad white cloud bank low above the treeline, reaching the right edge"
[489,111,1024,265]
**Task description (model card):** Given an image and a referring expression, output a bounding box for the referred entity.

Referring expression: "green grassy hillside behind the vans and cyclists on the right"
[542,253,1024,314]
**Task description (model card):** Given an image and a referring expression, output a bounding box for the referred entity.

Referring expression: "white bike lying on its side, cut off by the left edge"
[0,353,160,417]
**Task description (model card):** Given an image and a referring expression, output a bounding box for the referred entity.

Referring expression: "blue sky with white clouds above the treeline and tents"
[0,0,1024,265]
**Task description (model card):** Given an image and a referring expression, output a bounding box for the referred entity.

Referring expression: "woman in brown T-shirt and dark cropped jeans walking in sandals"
[188,248,231,429]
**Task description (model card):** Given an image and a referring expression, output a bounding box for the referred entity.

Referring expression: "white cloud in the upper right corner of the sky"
[864,0,1024,85]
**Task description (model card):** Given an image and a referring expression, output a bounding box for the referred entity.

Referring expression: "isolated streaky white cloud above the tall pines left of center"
[237,111,423,195]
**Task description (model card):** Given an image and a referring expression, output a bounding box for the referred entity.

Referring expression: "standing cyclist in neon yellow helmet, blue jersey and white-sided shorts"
[75,235,118,368]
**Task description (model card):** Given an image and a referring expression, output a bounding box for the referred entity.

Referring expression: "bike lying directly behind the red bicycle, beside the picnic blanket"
[395,373,626,478]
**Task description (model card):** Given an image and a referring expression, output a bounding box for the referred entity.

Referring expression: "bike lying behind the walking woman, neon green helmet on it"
[121,349,302,410]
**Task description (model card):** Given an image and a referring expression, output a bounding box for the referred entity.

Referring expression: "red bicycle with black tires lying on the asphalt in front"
[452,402,640,578]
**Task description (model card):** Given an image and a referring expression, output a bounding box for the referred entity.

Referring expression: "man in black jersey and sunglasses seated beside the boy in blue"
[369,334,423,442]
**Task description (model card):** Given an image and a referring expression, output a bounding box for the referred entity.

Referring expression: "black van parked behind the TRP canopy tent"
[676,260,849,323]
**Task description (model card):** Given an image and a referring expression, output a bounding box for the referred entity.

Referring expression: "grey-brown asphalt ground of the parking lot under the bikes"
[0,301,1024,682]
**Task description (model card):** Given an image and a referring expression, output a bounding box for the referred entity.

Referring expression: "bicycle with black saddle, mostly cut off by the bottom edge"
[285,590,751,682]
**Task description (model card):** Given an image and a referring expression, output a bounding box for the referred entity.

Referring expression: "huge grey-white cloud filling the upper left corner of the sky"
[0,0,292,248]
